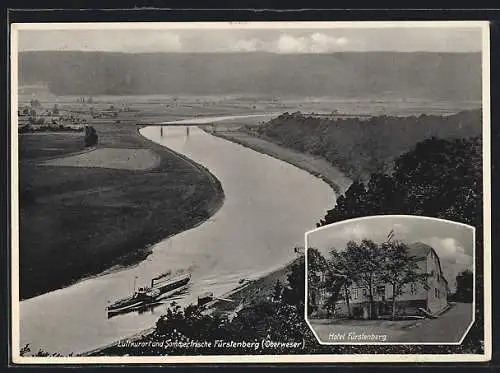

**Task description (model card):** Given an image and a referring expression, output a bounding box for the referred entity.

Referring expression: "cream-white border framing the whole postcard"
[10,21,492,365]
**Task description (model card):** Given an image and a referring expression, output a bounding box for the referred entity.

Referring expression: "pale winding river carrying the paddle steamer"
[20,117,334,354]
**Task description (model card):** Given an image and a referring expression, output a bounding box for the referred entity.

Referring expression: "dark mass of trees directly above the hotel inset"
[317,137,483,228]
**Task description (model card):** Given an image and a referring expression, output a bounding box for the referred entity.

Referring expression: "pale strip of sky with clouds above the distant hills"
[19,27,482,53]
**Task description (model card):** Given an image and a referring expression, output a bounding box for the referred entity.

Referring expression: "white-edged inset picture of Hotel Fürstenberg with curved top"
[306,215,475,344]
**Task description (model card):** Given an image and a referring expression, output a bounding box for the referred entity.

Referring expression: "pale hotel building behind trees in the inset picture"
[319,242,449,318]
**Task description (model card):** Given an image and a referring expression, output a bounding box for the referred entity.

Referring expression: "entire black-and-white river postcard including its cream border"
[10,21,491,364]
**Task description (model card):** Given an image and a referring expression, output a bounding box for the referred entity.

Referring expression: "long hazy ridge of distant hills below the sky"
[19,51,481,100]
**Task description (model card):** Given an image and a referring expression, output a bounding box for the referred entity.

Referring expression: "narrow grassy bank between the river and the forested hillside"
[203,127,352,195]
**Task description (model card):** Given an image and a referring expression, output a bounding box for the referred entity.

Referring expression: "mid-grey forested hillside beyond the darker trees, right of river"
[252,110,482,180]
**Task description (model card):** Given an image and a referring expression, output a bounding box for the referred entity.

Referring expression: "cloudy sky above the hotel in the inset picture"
[307,216,474,291]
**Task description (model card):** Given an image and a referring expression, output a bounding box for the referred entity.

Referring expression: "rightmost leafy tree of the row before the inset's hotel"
[380,241,429,319]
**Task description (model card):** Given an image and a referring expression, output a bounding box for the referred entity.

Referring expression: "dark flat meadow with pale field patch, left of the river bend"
[19,121,224,300]
